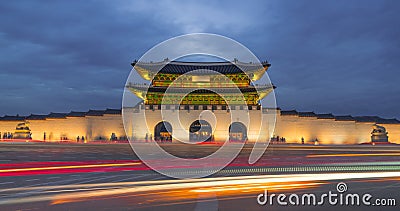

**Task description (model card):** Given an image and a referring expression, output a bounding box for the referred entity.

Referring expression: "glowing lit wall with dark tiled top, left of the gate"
[0,109,126,142]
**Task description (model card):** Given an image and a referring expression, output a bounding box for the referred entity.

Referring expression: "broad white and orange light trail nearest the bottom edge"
[0,171,400,206]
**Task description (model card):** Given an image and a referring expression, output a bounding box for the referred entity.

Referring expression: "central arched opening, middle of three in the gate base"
[189,120,213,142]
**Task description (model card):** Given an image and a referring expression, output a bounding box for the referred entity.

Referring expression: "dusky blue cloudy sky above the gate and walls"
[0,0,400,118]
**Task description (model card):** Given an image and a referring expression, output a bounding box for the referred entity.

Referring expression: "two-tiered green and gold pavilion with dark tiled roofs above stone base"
[128,60,273,106]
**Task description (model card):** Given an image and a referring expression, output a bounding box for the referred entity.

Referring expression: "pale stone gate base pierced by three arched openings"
[127,106,272,142]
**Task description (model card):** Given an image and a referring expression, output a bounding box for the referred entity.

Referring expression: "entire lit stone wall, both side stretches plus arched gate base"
[0,108,400,144]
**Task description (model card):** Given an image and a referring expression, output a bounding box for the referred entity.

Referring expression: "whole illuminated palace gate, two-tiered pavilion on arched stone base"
[126,60,274,142]
